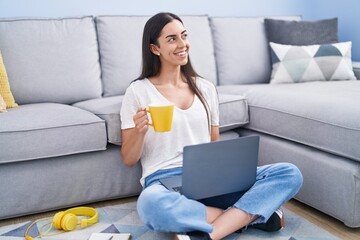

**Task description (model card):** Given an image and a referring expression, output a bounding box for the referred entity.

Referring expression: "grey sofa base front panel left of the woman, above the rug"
[0,145,141,218]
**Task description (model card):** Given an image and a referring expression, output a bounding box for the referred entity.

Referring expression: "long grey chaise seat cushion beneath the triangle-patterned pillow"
[219,81,360,161]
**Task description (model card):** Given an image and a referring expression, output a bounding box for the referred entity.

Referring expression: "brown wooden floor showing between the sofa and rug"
[0,197,360,240]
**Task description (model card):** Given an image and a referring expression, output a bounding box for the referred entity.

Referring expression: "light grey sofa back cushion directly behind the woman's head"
[96,15,216,96]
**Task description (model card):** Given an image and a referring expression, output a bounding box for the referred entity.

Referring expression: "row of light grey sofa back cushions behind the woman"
[0,15,301,104]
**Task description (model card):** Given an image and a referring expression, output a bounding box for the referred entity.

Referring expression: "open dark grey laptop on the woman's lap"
[160,135,259,208]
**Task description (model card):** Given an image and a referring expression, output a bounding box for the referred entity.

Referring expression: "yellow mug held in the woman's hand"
[147,104,174,132]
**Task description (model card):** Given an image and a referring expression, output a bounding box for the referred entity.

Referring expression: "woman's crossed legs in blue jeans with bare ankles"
[137,163,302,240]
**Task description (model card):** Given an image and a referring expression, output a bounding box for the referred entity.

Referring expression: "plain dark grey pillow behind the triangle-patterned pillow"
[265,18,338,45]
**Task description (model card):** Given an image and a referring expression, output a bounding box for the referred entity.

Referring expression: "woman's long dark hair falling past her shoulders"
[134,12,211,131]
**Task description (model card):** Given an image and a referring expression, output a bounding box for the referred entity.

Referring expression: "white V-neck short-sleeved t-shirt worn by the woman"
[120,78,219,185]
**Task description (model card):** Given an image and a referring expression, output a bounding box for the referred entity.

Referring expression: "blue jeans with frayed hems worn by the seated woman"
[137,163,303,233]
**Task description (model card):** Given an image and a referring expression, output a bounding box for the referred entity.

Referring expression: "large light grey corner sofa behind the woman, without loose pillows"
[0,15,360,227]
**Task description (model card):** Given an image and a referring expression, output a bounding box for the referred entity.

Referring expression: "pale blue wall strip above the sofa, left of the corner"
[0,0,302,17]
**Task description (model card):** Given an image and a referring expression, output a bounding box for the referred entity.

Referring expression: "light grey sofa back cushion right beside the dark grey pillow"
[210,16,300,85]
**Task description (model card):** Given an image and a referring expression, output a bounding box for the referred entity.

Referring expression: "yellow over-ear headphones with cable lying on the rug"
[24,207,99,240]
